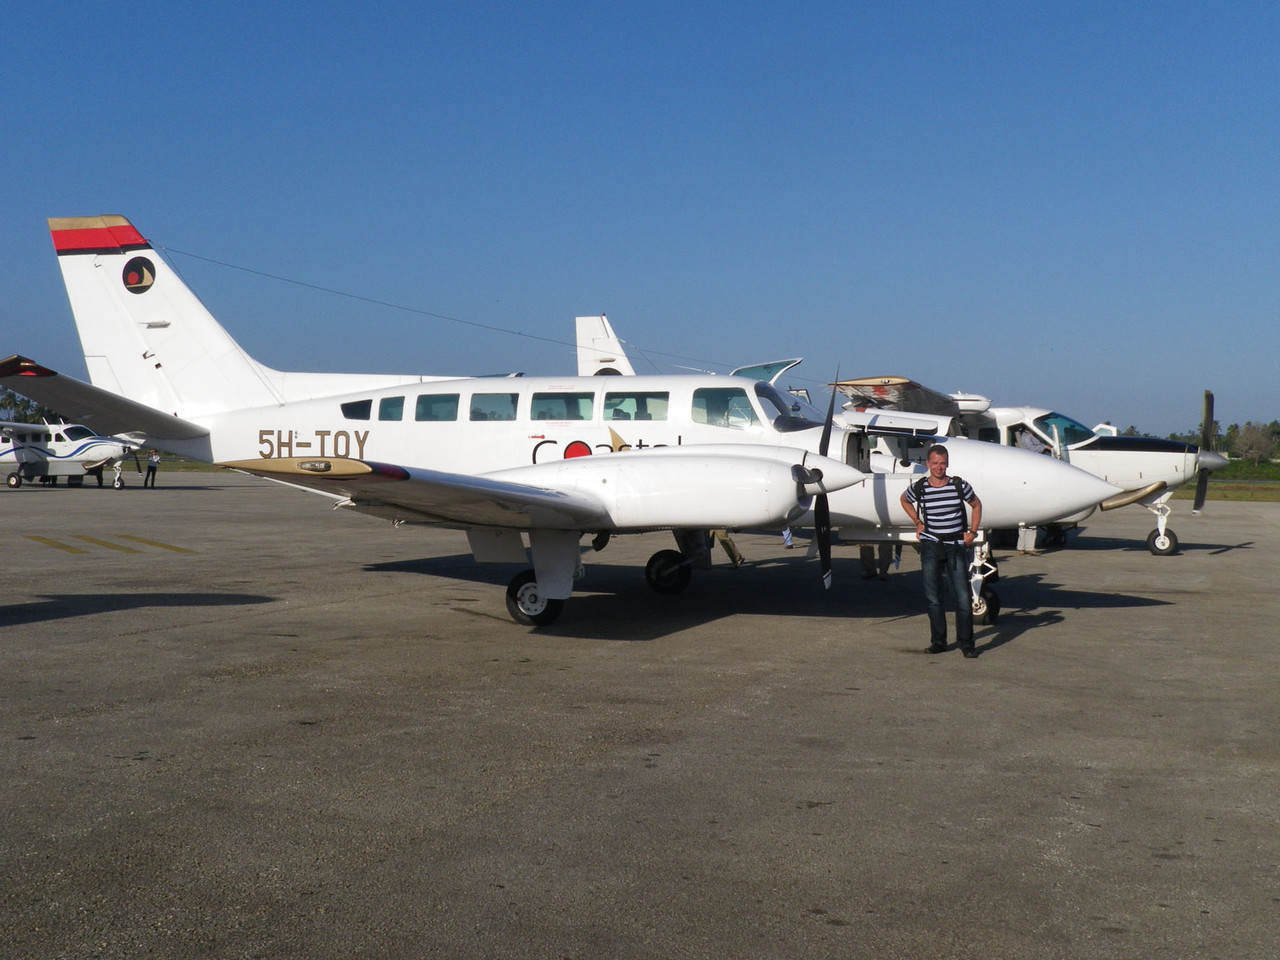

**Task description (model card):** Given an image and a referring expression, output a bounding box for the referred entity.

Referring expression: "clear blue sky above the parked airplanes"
[0,0,1280,434]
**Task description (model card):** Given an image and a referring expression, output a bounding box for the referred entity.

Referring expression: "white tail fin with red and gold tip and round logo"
[49,216,282,419]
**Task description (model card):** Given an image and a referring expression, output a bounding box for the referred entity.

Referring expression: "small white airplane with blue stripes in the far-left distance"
[0,421,136,490]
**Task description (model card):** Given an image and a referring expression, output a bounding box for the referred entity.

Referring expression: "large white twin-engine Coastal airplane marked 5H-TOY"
[0,216,1116,625]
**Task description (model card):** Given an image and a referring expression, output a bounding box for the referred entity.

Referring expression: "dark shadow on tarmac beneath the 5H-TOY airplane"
[365,554,1169,649]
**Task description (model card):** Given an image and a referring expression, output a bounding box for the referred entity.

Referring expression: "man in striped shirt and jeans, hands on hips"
[902,444,982,658]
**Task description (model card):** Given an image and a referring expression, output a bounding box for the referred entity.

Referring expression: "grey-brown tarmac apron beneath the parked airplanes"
[0,468,1280,960]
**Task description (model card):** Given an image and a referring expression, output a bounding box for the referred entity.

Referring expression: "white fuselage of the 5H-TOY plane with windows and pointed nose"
[154,375,1115,539]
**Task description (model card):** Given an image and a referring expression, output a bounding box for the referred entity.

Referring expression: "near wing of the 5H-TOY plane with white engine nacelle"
[220,444,865,532]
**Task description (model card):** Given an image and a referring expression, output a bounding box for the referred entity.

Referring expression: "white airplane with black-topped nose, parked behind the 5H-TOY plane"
[836,376,1226,557]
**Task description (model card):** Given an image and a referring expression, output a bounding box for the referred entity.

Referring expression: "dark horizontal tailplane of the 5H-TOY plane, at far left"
[0,355,209,440]
